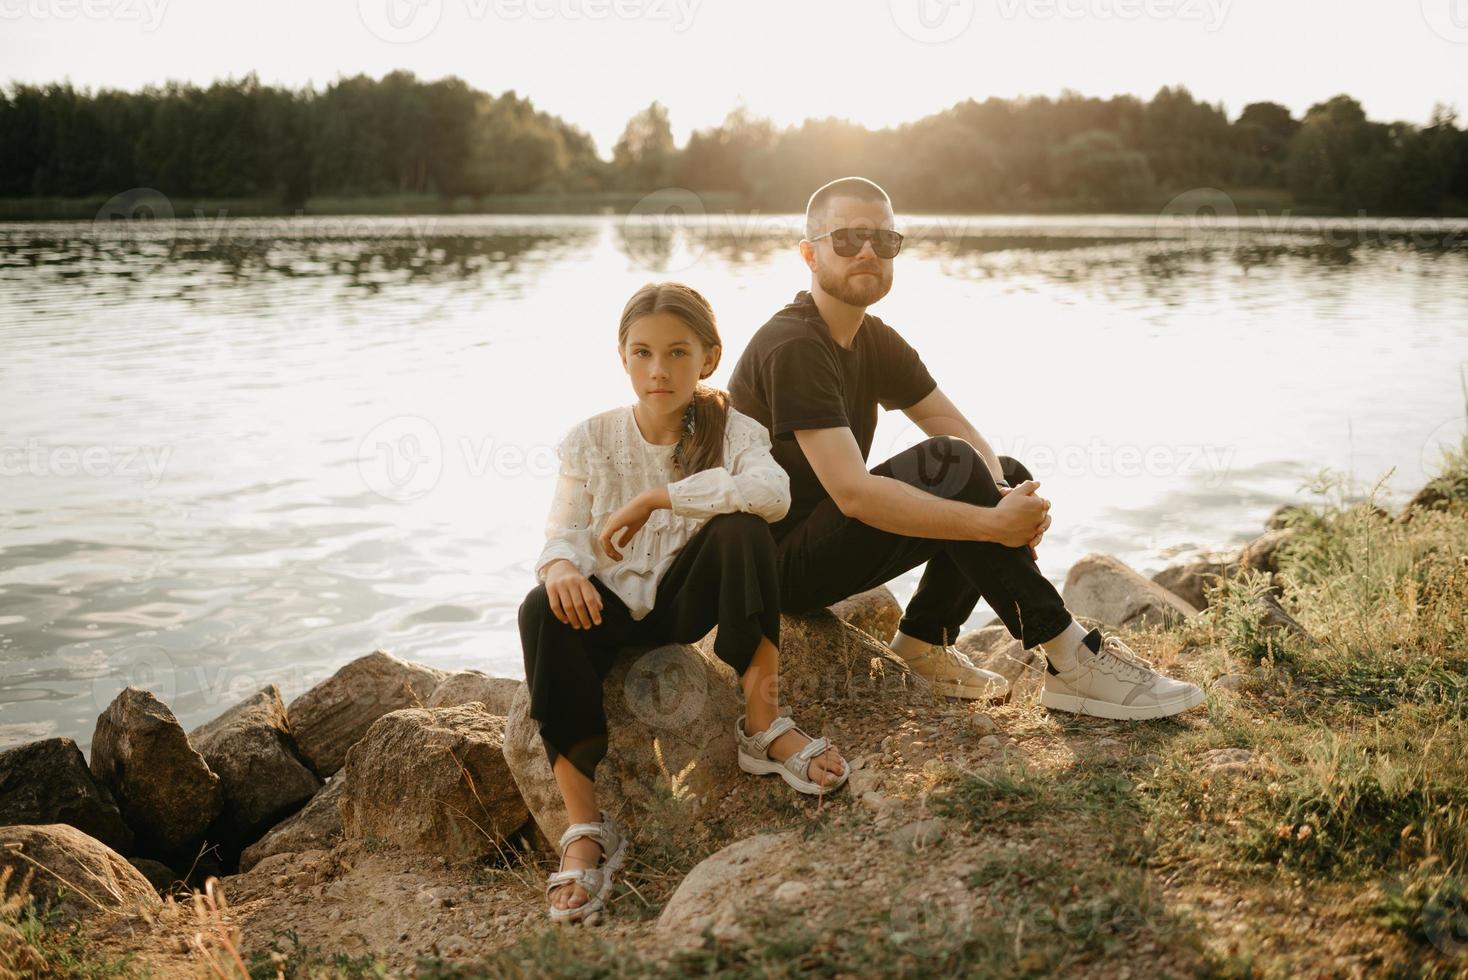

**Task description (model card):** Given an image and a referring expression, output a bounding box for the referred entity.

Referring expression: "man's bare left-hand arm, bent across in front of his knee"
[796,425,1045,547]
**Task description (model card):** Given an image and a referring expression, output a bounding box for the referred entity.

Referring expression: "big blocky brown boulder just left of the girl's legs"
[341,701,528,858]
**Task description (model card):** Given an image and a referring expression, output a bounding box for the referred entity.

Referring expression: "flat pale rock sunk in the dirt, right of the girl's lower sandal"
[658,830,798,940]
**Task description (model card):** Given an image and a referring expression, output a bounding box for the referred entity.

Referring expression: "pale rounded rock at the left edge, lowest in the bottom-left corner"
[0,823,161,918]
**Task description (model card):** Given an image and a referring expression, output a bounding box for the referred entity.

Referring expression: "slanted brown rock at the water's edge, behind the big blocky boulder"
[288,650,448,779]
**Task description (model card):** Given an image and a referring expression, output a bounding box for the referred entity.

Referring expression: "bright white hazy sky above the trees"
[0,0,1468,156]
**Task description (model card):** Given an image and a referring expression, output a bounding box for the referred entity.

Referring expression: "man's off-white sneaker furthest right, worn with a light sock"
[1039,629,1204,720]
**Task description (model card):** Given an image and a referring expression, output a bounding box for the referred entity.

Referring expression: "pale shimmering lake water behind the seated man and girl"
[0,216,1468,748]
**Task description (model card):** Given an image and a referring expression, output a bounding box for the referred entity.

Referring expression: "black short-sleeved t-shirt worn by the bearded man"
[730,289,937,538]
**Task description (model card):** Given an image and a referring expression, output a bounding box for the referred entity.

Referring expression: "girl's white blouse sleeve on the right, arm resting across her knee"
[668,412,790,524]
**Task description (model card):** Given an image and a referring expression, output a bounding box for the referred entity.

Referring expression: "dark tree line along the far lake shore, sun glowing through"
[0,72,1468,214]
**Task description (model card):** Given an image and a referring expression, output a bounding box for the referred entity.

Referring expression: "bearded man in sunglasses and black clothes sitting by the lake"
[730,178,1204,719]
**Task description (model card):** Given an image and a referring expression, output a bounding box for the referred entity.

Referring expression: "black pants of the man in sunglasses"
[775,436,1072,650]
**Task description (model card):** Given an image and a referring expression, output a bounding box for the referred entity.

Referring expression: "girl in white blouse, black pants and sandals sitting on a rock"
[520,283,849,921]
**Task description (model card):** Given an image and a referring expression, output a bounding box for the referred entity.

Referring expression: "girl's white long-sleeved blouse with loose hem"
[536,405,790,619]
